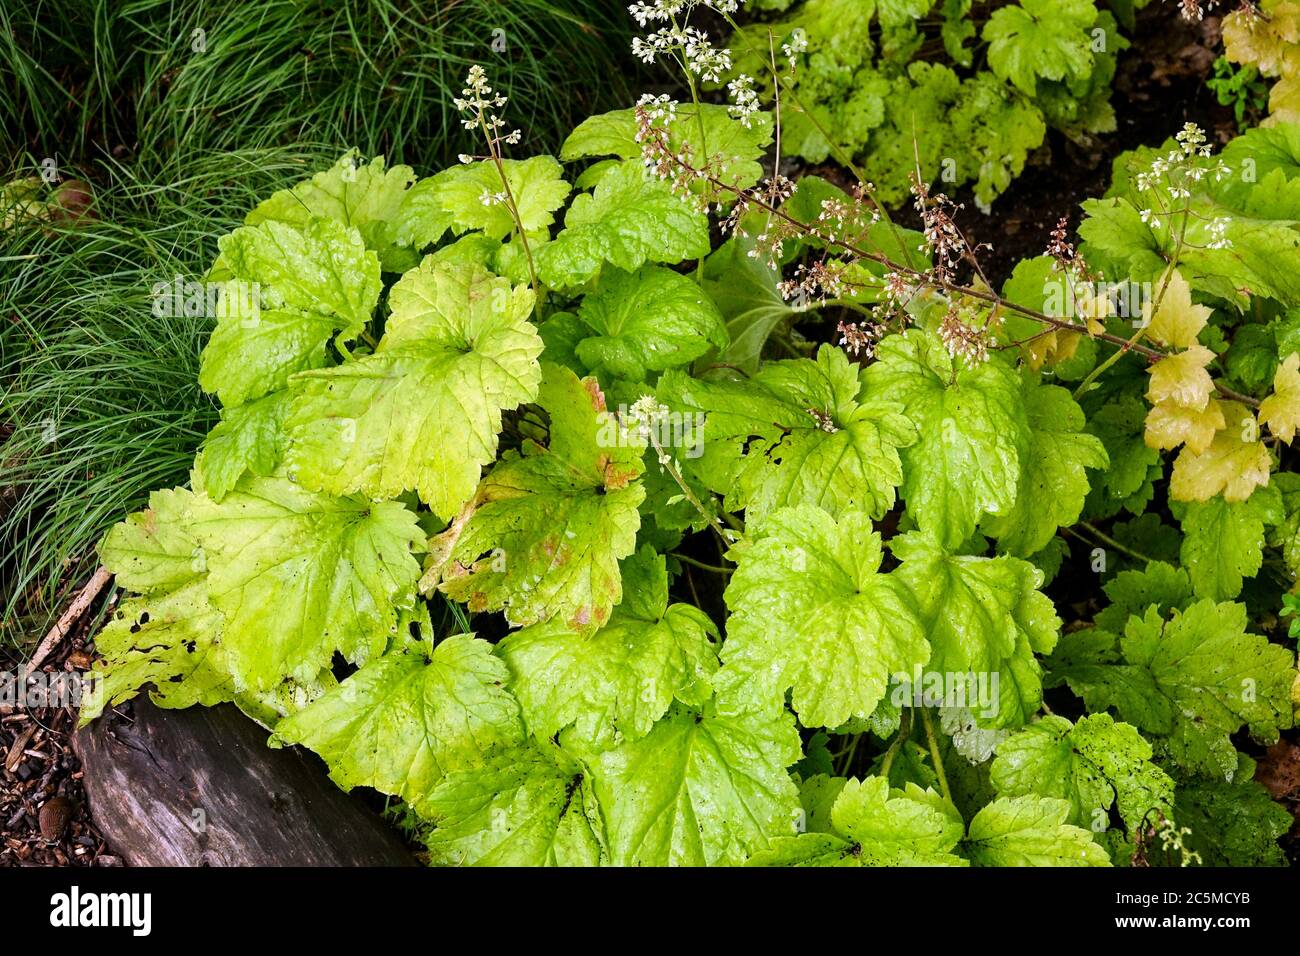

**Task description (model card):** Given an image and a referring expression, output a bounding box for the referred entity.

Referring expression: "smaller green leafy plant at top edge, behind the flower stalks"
[732,0,1144,207]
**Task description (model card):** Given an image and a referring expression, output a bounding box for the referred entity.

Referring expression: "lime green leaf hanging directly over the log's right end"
[272,635,523,810]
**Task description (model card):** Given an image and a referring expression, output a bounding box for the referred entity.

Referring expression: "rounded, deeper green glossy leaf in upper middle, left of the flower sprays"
[576,265,727,381]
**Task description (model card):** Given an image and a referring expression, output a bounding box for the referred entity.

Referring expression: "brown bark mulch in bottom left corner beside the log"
[0,608,121,866]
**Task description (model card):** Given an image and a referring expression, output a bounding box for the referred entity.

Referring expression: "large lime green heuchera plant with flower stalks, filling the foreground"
[83,3,1300,865]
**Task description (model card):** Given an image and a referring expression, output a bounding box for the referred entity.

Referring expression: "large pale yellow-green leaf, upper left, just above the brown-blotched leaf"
[287,263,542,518]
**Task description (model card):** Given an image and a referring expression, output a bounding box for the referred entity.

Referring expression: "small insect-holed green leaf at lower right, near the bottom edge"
[992,714,1174,835]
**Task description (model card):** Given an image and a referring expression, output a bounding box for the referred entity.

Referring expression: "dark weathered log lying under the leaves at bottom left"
[73,698,415,866]
